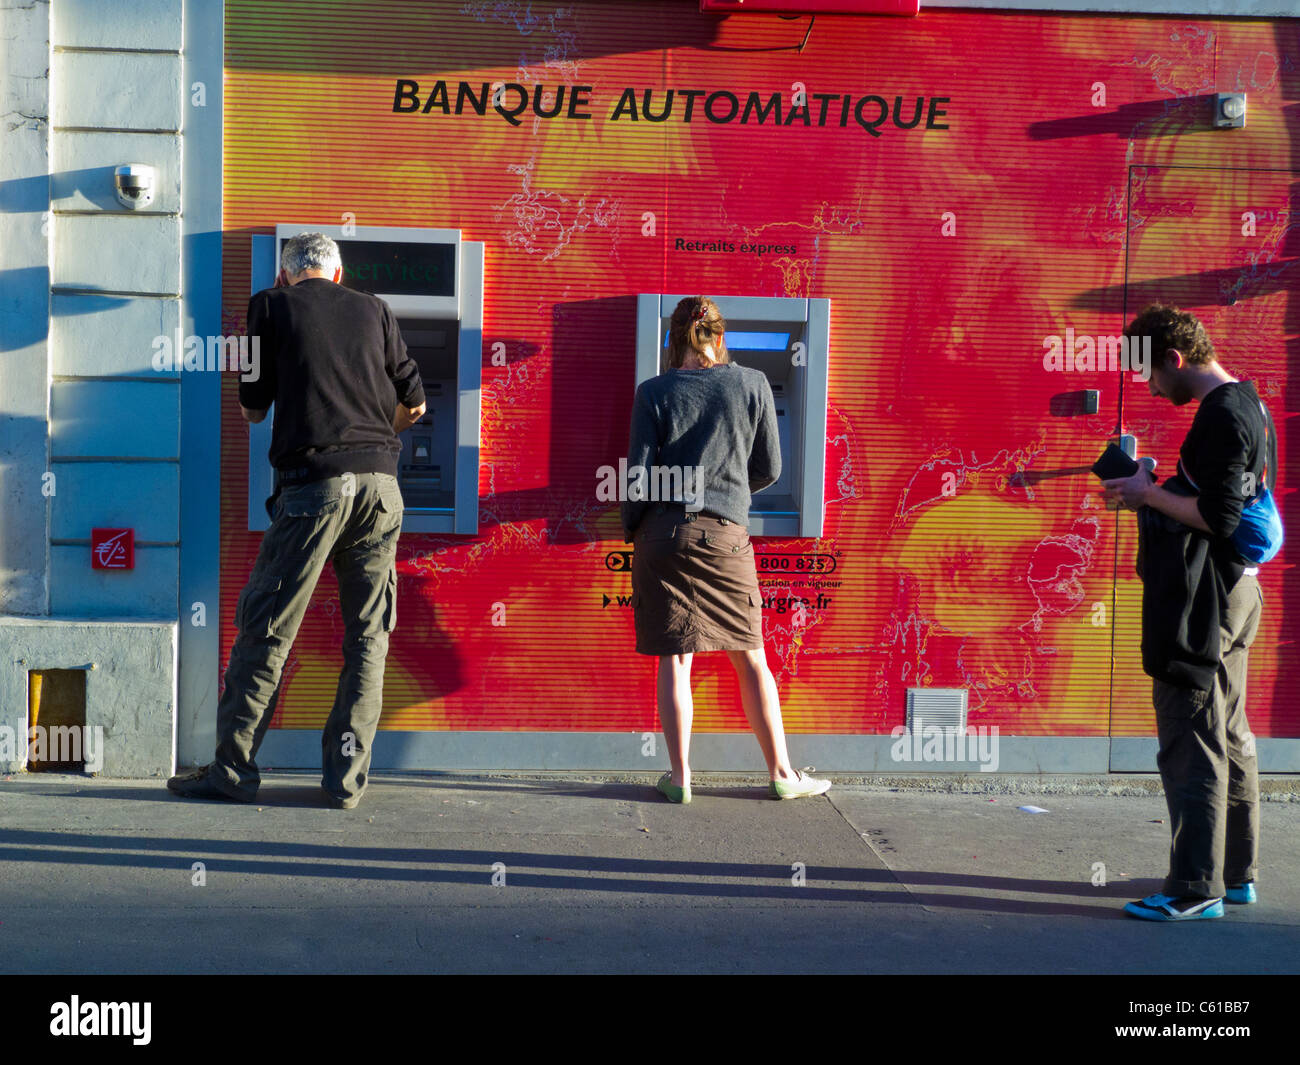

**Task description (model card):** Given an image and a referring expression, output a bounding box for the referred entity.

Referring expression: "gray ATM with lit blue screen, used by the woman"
[637,293,831,537]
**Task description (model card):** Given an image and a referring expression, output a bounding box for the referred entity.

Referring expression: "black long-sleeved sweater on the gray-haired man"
[239,277,424,484]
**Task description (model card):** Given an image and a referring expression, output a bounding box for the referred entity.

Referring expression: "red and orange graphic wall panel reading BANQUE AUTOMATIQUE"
[221,0,1300,736]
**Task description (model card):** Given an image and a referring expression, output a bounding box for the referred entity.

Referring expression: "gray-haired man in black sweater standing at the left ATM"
[168,233,425,809]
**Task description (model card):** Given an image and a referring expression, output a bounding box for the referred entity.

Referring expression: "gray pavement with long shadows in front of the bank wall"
[0,772,1300,974]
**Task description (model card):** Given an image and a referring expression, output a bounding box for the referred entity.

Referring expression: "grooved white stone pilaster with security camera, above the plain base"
[49,0,185,618]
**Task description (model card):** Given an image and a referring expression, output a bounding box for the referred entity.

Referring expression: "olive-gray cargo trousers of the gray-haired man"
[209,473,402,798]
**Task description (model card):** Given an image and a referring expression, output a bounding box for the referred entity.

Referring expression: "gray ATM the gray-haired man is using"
[248,225,484,534]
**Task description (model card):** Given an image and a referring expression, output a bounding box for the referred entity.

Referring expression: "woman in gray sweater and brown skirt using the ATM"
[621,296,831,802]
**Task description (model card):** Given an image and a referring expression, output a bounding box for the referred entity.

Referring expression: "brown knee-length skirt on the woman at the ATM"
[632,505,763,655]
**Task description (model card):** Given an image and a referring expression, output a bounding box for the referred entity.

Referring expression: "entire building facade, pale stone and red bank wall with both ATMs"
[0,0,1300,776]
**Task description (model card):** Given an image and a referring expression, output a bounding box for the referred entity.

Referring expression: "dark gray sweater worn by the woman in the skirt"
[621,363,781,544]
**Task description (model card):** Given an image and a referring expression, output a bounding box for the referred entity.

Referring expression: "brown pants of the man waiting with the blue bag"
[1152,576,1264,899]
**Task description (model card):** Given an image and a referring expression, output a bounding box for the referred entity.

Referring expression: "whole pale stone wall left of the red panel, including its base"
[0,0,183,776]
